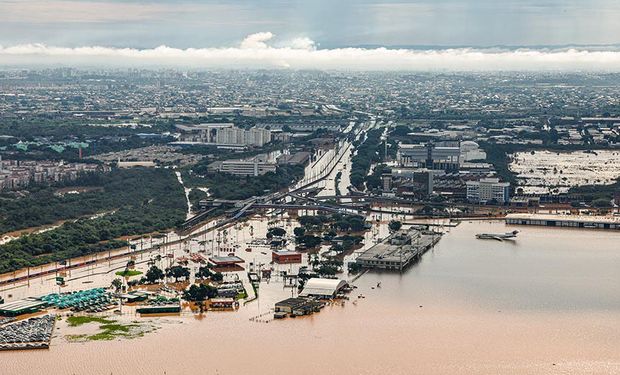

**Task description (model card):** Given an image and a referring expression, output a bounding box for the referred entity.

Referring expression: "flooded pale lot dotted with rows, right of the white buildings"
[509,150,620,194]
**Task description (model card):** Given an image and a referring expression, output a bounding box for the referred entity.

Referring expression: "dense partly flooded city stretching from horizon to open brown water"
[0,68,620,374]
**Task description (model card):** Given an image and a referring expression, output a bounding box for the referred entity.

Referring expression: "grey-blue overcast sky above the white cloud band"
[0,0,620,48]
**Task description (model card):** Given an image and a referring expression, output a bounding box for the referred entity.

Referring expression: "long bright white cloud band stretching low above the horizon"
[0,32,620,71]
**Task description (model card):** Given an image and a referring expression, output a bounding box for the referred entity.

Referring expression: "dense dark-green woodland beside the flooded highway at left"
[0,168,187,273]
